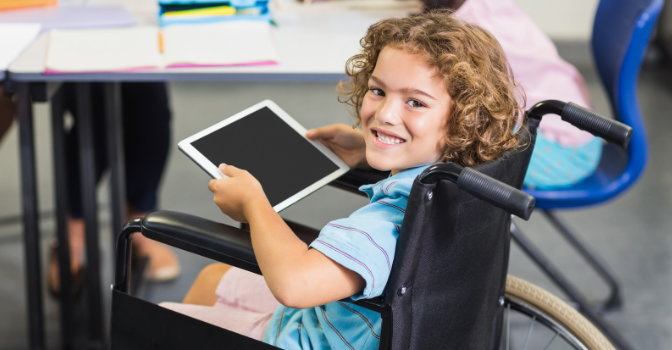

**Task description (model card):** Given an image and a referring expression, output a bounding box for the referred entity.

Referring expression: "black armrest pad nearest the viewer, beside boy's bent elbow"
[142,210,261,274]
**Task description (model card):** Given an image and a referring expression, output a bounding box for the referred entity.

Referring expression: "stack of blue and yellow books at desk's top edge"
[159,0,271,27]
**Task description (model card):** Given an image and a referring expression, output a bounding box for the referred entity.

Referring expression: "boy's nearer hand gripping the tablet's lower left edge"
[208,164,271,222]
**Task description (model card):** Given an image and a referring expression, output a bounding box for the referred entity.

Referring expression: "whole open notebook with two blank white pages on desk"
[45,21,279,73]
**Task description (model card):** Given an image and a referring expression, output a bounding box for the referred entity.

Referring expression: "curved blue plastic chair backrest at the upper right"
[591,0,663,194]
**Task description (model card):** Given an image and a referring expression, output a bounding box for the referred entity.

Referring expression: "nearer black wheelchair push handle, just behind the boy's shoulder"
[420,163,535,220]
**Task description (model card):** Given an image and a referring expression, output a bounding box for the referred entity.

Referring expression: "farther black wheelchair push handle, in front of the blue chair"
[527,100,632,148]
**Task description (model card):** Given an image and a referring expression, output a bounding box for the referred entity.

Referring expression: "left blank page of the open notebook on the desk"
[45,26,162,73]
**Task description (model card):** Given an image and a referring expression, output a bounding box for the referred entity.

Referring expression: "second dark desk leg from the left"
[51,88,74,350]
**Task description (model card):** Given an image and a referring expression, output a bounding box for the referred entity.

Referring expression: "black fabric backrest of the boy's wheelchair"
[385,128,536,349]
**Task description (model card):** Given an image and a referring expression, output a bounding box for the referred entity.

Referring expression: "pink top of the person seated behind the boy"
[455,0,593,147]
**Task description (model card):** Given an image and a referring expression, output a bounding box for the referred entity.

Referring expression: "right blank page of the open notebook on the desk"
[163,20,279,66]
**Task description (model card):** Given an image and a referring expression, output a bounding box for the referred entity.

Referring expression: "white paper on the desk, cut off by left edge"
[0,23,40,71]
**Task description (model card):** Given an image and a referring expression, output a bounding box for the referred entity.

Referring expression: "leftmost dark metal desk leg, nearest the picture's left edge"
[17,83,45,350]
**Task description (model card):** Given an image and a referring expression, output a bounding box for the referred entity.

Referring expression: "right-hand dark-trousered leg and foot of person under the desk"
[121,83,180,281]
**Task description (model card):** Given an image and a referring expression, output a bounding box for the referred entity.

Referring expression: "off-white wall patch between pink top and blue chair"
[513,0,599,41]
